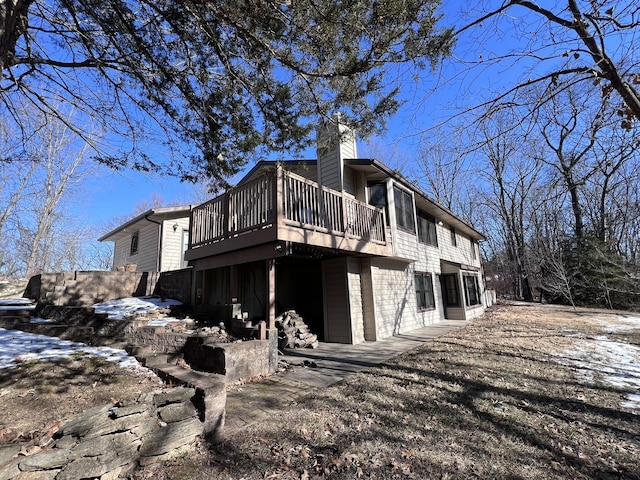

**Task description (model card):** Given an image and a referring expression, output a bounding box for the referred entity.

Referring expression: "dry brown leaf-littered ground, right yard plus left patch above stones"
[0,304,640,480]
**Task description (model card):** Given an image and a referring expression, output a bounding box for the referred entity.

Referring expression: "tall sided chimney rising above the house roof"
[316,113,358,191]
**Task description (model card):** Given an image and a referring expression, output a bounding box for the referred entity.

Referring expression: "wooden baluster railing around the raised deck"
[190,170,386,249]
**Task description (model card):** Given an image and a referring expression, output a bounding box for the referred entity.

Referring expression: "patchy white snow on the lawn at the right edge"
[559,315,640,414]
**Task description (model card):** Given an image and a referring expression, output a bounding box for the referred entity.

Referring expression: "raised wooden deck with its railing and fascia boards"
[185,168,392,260]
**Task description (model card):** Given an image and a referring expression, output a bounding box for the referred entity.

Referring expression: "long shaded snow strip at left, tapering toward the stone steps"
[0,328,155,377]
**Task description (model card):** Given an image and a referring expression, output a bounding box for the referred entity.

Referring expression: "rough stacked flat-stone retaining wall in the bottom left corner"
[0,387,205,480]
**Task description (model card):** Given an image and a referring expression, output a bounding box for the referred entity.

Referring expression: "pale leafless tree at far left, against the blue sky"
[0,105,91,276]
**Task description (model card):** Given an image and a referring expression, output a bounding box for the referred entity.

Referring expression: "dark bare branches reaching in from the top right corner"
[455,0,640,125]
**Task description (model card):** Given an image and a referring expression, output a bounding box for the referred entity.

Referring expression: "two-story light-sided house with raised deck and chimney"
[185,122,484,343]
